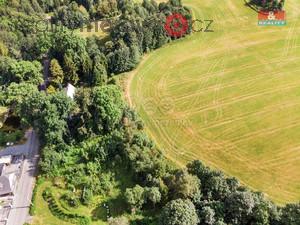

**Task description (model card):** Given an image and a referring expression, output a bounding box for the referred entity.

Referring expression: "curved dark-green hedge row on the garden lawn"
[43,188,91,225]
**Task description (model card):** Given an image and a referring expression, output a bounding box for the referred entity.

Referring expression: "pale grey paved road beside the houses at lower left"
[0,130,39,225]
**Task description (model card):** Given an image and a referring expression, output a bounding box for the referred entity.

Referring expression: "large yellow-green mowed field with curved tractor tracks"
[128,0,300,204]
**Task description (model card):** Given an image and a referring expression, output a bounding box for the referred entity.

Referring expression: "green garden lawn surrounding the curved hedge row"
[32,168,143,225]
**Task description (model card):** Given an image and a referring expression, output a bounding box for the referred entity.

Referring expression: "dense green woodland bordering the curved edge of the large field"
[0,0,300,225]
